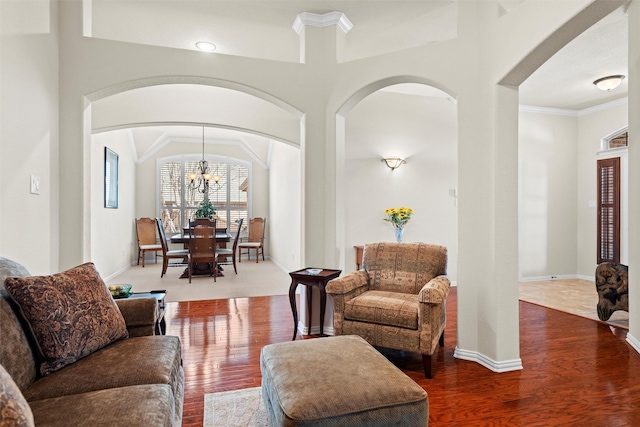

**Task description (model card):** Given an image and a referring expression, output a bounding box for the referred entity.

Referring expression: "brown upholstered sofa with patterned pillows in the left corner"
[0,257,184,426]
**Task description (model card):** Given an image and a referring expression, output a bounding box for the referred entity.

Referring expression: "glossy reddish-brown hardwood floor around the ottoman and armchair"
[167,288,640,427]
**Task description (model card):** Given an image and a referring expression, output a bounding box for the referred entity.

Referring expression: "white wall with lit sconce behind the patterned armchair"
[345,91,458,281]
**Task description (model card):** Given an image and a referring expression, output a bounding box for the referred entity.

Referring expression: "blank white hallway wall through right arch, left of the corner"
[518,112,580,280]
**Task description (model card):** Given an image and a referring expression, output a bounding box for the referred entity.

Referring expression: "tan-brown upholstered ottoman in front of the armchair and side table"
[260,335,429,427]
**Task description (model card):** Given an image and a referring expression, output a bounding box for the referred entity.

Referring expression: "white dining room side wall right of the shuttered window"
[265,142,304,271]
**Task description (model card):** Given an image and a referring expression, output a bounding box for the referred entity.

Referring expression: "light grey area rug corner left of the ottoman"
[203,387,267,427]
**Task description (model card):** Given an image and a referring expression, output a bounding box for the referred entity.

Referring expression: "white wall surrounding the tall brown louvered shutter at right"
[577,104,629,279]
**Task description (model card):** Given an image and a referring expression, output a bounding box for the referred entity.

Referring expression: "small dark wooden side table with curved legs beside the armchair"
[289,268,342,341]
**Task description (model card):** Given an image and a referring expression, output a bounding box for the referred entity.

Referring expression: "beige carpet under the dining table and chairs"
[107,260,291,302]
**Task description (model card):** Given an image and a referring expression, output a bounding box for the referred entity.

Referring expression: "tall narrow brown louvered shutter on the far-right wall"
[598,157,620,264]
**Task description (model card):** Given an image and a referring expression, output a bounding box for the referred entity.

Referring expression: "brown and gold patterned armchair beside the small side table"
[326,243,451,378]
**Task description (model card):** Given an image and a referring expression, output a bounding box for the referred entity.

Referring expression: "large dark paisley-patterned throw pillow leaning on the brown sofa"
[5,262,129,375]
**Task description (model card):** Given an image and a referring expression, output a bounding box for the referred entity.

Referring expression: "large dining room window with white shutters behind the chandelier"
[158,156,251,234]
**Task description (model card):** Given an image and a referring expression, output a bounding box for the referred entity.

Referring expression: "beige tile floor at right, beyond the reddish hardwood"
[520,279,629,329]
